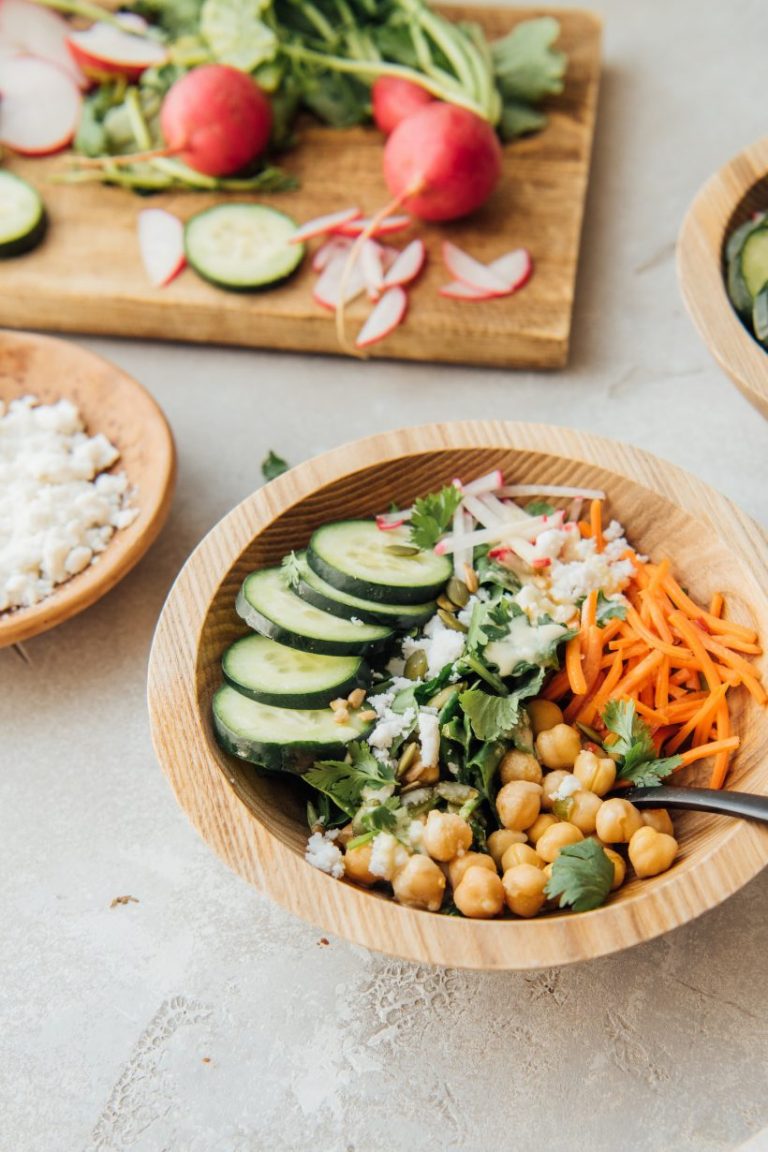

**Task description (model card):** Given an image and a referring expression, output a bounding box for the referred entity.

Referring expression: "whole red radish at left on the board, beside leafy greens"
[160,65,272,176]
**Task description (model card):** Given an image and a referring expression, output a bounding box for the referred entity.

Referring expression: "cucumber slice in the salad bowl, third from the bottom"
[235,568,394,655]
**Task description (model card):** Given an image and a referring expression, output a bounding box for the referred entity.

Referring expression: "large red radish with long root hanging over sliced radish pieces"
[383,100,502,220]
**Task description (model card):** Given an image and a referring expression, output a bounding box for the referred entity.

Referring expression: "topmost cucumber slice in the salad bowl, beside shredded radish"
[306,520,453,604]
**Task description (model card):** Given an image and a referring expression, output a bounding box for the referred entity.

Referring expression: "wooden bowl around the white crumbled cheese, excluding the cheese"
[0,331,176,647]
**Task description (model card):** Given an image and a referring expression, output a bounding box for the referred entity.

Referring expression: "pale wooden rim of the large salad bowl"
[147,422,768,970]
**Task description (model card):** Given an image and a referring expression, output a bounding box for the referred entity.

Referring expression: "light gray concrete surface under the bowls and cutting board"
[0,0,768,1152]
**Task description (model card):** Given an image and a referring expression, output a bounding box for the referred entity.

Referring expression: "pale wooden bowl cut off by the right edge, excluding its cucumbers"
[677,136,768,417]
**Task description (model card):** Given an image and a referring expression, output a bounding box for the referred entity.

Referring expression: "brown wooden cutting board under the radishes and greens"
[0,7,601,367]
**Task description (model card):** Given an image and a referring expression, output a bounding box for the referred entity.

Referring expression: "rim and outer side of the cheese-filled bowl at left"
[0,328,176,649]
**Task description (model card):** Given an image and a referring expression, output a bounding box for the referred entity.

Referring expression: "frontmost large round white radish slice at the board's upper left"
[0,56,83,156]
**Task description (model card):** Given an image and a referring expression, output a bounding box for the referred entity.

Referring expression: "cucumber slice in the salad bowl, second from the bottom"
[221,635,371,708]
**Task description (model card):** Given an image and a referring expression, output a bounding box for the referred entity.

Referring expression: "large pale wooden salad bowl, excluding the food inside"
[149,420,768,969]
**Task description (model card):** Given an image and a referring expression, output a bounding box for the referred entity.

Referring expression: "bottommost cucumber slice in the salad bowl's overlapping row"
[213,684,372,773]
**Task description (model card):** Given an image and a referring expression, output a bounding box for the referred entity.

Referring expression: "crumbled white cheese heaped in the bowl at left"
[0,396,138,612]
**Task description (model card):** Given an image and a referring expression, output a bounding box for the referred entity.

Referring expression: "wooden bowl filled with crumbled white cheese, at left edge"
[0,331,176,647]
